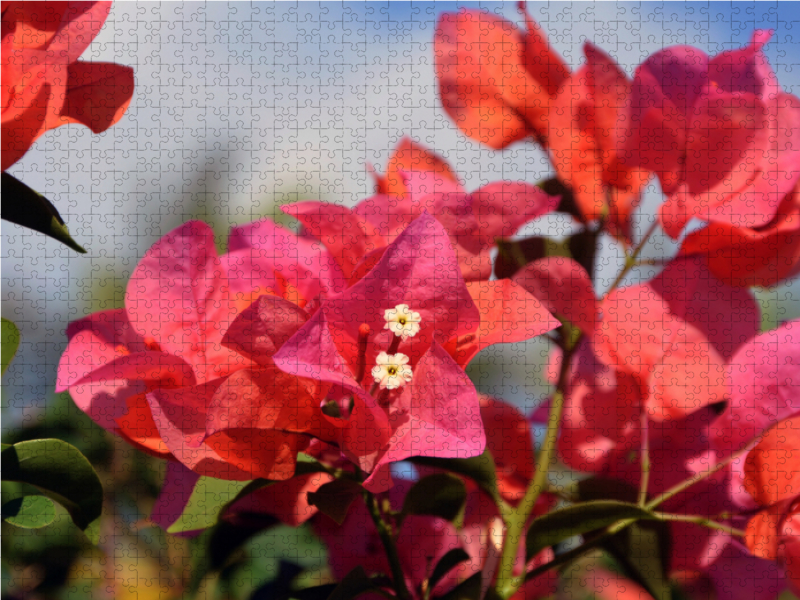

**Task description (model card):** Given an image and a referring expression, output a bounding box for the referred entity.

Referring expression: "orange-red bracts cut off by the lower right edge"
[744,417,800,593]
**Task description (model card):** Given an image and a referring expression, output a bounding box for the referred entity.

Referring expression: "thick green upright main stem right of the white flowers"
[496,335,581,598]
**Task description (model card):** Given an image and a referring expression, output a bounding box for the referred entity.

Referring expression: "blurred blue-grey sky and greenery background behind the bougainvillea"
[1,2,800,599]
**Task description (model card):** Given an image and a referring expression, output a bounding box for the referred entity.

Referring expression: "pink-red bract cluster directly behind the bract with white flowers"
[282,139,559,283]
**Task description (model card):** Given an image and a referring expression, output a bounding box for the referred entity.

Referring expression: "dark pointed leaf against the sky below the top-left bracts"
[0,173,86,254]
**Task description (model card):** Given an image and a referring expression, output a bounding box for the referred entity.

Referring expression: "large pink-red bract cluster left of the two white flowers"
[58,221,334,479]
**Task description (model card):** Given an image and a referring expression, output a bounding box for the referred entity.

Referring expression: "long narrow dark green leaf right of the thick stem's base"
[525,500,657,562]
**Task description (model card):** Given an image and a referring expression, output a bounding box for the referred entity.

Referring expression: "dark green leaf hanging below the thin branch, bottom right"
[602,521,672,600]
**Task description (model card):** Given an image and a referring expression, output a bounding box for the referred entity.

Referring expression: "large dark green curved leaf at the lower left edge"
[0,439,103,544]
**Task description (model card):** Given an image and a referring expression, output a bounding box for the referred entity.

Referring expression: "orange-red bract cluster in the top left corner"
[0,2,133,171]
